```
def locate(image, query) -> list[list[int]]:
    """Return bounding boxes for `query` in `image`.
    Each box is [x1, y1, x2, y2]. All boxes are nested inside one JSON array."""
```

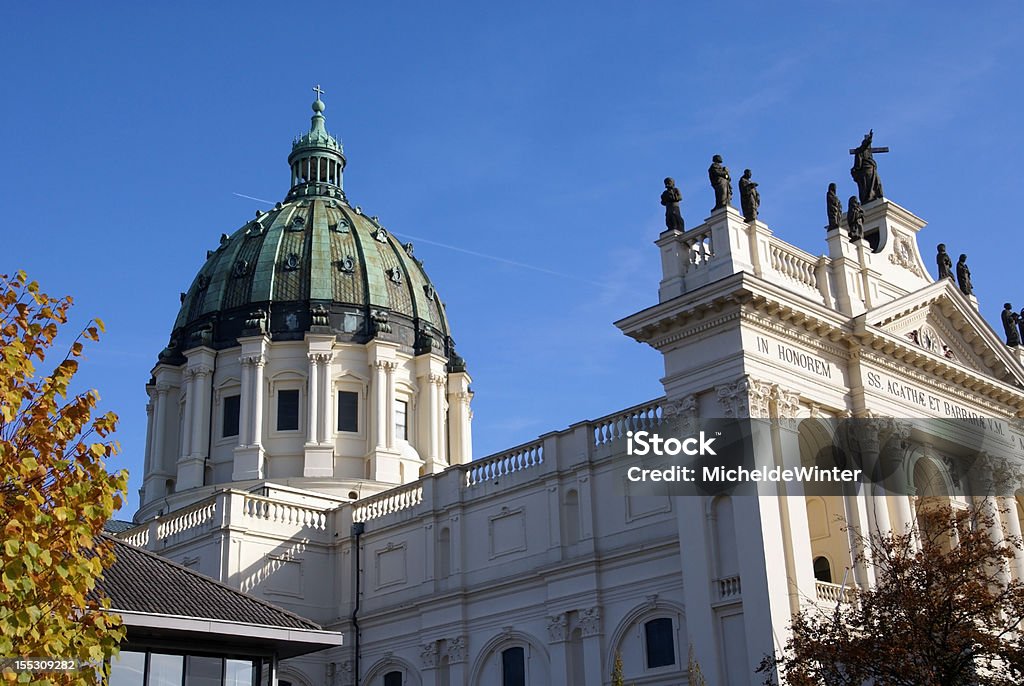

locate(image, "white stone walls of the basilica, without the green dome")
[[123, 200, 1024, 686]]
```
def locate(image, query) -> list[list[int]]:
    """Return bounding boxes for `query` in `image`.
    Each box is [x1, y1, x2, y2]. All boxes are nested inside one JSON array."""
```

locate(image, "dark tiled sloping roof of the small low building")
[[97, 535, 321, 631]]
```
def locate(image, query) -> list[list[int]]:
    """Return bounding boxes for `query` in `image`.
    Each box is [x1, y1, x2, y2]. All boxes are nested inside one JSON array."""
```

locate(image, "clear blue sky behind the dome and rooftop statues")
[[0, 1, 1024, 512]]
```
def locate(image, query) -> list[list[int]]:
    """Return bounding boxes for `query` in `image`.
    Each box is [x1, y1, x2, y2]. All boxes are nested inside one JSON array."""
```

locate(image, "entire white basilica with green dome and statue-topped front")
[[117, 92, 1024, 686]]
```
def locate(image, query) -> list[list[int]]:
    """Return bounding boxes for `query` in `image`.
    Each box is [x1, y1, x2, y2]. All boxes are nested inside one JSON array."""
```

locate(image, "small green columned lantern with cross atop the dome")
[[288, 84, 345, 201]]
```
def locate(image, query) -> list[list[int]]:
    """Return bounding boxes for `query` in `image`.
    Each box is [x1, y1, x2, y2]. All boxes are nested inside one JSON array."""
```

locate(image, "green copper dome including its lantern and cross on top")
[[160, 93, 462, 368]]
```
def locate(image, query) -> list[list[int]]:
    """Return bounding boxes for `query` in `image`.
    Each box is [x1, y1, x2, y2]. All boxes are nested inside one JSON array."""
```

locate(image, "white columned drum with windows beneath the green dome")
[[136, 333, 472, 520]]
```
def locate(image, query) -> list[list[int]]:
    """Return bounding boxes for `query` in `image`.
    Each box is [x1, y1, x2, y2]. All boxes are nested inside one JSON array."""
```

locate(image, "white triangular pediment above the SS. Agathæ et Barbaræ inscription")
[[857, 280, 1024, 387]]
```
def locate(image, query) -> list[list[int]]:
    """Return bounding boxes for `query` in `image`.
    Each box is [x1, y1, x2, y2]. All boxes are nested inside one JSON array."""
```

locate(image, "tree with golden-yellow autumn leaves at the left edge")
[[0, 272, 126, 684]]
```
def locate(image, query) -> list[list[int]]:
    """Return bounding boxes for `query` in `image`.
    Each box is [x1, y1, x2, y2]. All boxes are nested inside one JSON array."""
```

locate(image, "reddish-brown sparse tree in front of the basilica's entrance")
[[762, 506, 1024, 686]]
